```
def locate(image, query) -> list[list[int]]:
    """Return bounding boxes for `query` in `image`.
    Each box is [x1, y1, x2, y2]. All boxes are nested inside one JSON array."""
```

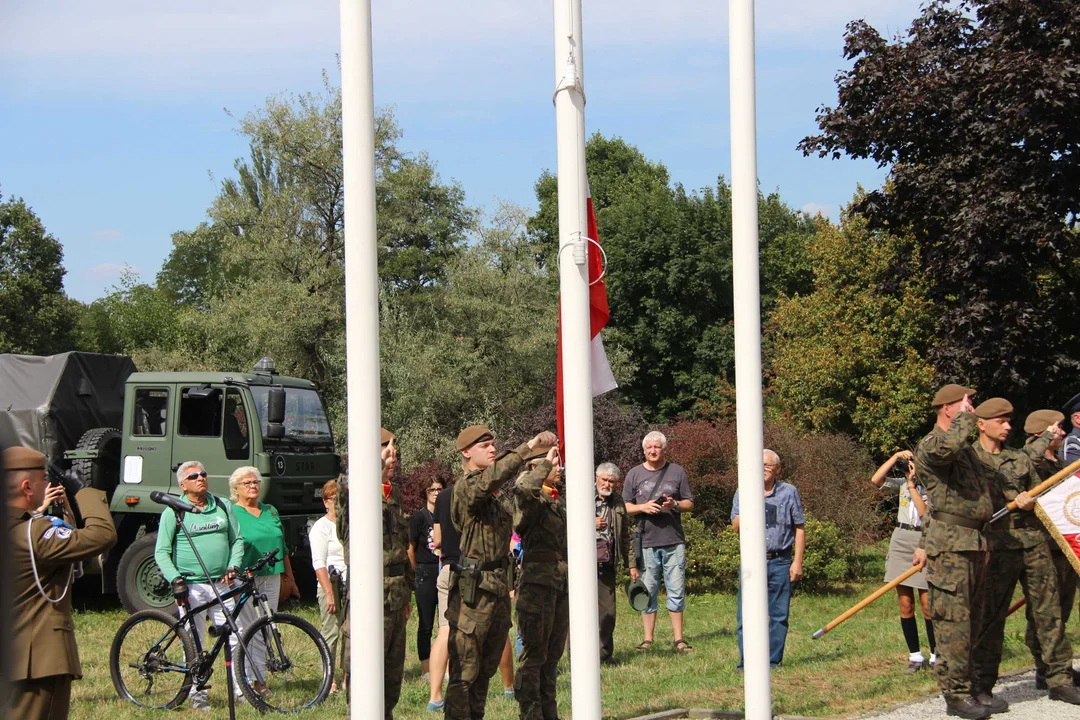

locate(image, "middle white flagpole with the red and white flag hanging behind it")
[[554, 0, 600, 720]]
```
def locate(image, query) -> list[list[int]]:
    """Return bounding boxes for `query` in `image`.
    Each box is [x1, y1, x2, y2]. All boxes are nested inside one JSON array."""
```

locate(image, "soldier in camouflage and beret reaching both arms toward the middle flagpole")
[[445, 425, 557, 720]]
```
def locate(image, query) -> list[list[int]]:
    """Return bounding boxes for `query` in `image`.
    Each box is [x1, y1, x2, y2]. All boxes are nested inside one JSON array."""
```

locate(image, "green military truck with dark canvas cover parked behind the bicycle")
[[0, 352, 340, 612]]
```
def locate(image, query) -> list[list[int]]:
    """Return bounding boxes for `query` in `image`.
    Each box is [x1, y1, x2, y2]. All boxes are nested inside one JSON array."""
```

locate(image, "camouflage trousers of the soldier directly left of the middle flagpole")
[[514, 583, 570, 720]]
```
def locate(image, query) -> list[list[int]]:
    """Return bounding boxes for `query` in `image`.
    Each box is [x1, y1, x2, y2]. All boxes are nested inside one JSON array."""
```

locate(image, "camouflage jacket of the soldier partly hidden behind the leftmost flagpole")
[[336, 475, 414, 613]]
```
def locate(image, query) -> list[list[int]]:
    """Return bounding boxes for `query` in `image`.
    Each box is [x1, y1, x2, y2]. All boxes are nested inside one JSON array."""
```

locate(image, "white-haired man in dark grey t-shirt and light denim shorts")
[[622, 432, 693, 653]]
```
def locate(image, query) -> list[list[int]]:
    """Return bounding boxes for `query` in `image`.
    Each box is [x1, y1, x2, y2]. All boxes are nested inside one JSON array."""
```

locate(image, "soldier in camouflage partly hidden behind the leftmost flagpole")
[[337, 429, 413, 720]]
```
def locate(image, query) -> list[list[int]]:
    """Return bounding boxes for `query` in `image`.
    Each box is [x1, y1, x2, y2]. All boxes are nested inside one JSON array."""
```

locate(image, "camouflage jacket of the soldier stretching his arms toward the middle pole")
[[450, 444, 529, 598]]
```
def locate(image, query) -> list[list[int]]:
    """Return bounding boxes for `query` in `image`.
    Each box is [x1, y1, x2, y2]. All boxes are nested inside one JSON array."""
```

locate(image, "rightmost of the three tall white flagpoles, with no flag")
[[728, 0, 772, 720]]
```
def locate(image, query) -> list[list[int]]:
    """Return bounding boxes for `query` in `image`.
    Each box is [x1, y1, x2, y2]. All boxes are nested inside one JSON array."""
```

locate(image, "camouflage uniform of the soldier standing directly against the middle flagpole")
[[514, 460, 570, 720]]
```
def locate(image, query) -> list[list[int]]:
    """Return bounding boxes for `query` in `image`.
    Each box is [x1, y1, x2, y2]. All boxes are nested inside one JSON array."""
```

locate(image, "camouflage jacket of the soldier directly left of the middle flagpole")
[[514, 460, 566, 590]]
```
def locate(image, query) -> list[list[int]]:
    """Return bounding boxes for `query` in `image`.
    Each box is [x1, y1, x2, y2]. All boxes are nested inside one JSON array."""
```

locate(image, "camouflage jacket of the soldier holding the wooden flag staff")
[[974, 444, 1047, 549]]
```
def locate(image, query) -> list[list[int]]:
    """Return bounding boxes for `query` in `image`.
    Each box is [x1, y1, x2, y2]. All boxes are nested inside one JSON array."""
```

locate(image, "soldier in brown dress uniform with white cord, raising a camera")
[[3, 448, 117, 720]]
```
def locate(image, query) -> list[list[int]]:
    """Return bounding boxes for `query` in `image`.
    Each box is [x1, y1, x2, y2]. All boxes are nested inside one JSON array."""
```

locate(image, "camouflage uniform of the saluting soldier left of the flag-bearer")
[[915, 412, 994, 702]]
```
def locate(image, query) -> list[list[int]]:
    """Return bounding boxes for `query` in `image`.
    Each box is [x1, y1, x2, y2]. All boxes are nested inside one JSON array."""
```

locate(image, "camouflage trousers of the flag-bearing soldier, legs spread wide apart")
[[972, 542, 1072, 692]]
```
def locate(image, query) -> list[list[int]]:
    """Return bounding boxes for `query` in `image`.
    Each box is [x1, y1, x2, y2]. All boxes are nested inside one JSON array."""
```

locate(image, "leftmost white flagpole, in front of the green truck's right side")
[[341, 0, 383, 718]]
